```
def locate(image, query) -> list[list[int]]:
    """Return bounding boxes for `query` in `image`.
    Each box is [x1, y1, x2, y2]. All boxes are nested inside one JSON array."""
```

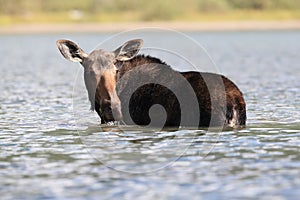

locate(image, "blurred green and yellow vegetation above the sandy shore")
[[0, 0, 300, 25]]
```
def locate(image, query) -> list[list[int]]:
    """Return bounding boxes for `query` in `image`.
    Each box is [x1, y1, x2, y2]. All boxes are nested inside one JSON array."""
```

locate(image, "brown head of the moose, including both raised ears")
[[56, 39, 143, 123]]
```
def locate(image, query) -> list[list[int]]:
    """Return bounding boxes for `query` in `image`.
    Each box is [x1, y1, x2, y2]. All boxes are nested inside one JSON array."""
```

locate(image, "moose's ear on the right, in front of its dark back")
[[114, 39, 143, 61]]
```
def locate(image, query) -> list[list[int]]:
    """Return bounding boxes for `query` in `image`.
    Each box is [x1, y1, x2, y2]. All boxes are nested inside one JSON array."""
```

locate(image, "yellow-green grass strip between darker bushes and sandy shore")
[[0, 10, 300, 25]]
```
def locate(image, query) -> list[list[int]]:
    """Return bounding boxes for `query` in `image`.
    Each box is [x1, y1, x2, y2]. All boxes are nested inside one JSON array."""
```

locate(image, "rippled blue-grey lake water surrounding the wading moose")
[[0, 31, 300, 199]]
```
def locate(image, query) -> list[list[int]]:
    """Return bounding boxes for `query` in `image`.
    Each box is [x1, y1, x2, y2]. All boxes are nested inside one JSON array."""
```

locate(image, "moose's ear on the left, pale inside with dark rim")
[[56, 40, 88, 62]]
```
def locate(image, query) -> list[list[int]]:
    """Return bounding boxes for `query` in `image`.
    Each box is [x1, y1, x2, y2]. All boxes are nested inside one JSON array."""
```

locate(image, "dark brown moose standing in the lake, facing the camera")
[[56, 39, 246, 128]]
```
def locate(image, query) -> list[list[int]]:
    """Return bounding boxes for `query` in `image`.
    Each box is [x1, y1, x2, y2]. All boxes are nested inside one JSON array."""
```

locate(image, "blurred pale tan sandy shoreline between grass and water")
[[0, 20, 300, 35]]
